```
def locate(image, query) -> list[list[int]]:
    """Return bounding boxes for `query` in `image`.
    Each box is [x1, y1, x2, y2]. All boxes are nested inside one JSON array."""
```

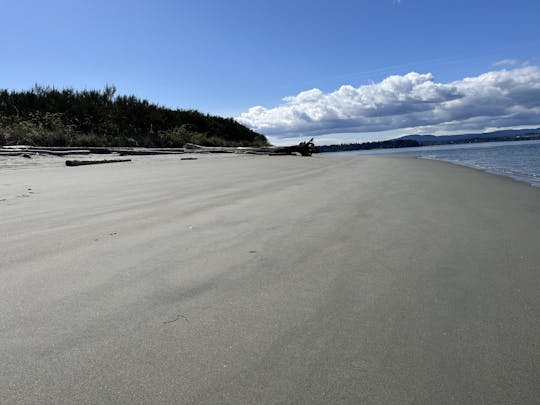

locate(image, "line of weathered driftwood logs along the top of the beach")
[[0, 139, 315, 160]]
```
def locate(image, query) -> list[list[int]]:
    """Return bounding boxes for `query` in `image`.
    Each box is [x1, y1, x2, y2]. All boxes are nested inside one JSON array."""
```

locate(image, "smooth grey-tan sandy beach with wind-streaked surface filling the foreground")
[[0, 156, 540, 404]]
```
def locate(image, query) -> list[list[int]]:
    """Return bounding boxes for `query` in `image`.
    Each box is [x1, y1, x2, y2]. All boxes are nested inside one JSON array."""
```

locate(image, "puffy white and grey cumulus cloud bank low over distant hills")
[[237, 66, 540, 138]]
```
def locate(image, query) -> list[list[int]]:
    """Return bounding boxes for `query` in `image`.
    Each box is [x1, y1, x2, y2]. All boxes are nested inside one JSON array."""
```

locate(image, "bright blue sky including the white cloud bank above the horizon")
[[0, 0, 540, 144]]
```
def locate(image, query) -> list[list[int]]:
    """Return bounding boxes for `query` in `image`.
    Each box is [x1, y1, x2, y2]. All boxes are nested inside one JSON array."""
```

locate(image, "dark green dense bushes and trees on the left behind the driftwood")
[[0, 86, 268, 147]]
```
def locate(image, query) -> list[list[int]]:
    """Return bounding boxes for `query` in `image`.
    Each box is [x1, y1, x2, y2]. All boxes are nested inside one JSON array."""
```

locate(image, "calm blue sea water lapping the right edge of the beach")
[[324, 141, 540, 187]]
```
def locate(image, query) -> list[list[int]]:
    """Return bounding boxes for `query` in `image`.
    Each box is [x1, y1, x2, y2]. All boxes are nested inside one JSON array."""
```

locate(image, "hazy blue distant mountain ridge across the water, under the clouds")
[[396, 128, 540, 146]]
